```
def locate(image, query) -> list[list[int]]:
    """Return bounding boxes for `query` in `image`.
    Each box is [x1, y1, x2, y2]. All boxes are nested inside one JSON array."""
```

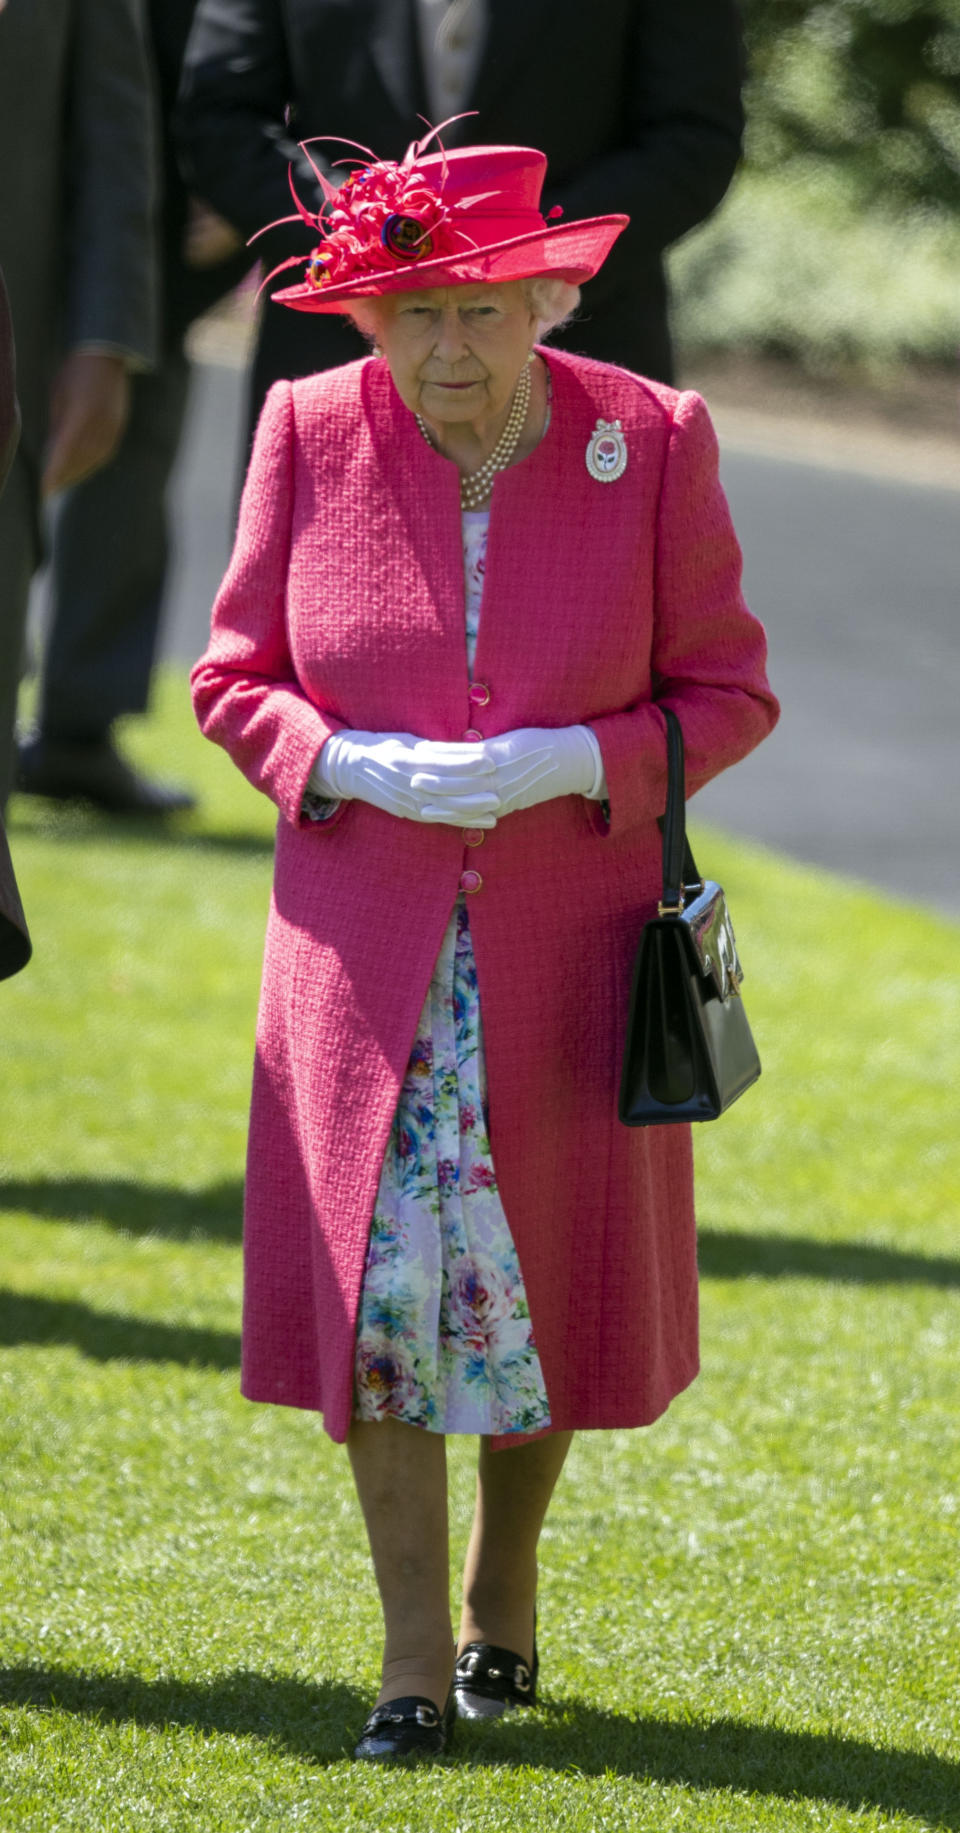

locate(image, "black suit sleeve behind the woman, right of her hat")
[[548, 0, 744, 258]]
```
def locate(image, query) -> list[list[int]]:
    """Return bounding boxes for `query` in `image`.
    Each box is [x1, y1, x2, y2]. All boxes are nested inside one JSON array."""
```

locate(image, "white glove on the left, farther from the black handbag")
[[308, 731, 500, 827]]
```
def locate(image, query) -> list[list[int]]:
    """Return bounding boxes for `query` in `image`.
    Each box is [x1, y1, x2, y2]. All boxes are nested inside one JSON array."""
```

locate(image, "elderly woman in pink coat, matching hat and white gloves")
[[192, 145, 777, 1760]]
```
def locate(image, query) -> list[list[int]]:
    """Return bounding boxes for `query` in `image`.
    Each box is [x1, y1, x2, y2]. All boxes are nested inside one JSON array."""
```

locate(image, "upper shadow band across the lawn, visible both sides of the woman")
[[7, 1177, 960, 1287]]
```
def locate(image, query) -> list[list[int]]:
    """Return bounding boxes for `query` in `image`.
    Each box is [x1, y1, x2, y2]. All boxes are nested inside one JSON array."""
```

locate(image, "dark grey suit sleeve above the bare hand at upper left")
[[60, 0, 158, 365]]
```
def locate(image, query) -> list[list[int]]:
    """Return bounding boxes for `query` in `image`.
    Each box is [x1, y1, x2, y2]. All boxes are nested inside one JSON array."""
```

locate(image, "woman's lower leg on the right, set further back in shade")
[[458, 1432, 573, 1664]]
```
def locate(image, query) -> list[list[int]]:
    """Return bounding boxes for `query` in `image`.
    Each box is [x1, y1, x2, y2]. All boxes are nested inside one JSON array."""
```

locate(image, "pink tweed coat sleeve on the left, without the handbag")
[[191, 381, 343, 832]]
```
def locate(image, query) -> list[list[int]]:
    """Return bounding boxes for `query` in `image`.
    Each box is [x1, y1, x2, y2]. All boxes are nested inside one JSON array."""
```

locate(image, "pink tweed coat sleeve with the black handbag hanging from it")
[[590, 394, 780, 834]]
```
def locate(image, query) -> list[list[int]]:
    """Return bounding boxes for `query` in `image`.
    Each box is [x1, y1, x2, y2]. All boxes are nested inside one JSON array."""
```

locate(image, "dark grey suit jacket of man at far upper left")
[[0, 0, 156, 450]]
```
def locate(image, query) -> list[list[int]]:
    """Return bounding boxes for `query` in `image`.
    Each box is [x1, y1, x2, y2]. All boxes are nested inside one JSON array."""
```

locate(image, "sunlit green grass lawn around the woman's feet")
[[0, 676, 960, 1833]]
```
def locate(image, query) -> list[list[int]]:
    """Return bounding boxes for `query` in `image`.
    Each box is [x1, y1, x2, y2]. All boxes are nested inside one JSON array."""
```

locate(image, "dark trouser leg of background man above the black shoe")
[[38, 350, 191, 742]]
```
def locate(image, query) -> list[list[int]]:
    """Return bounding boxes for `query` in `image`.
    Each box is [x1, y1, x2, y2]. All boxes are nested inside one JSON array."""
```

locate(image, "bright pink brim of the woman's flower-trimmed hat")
[[271, 216, 630, 312]]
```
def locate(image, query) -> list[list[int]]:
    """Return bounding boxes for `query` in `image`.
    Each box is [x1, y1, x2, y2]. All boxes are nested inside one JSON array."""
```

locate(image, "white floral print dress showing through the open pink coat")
[[354, 510, 550, 1435]]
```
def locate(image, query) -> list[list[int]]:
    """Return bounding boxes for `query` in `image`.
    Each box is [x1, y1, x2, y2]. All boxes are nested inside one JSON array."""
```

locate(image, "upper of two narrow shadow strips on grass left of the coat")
[[0, 1177, 244, 1241]]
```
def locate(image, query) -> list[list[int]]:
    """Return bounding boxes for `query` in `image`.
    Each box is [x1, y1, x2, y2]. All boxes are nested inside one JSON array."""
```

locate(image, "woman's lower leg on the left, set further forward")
[[346, 1419, 454, 1710]]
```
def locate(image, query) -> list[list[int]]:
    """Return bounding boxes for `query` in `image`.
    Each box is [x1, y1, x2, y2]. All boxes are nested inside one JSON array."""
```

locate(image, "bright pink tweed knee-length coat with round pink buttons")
[[192, 350, 777, 1439]]
